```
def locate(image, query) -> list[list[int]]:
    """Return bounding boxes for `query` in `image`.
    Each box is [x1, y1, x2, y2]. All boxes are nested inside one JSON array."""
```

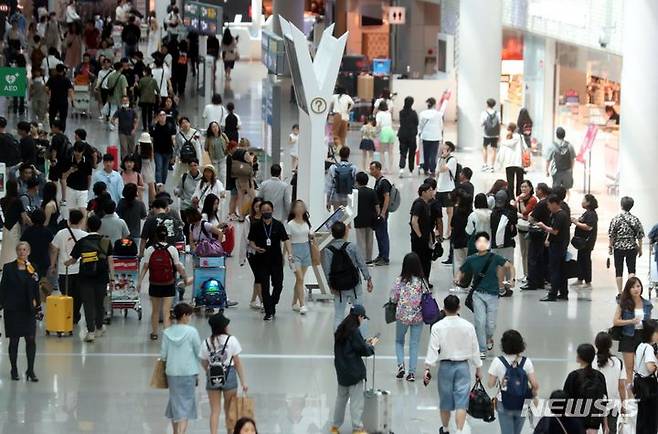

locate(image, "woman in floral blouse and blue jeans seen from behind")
[[389, 252, 429, 382]]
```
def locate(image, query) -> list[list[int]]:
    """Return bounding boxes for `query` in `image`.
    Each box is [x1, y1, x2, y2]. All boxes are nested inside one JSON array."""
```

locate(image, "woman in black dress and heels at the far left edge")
[[0, 241, 41, 383]]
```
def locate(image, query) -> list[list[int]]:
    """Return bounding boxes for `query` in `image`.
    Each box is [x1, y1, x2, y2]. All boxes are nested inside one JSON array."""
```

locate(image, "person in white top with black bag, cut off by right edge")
[[633, 320, 658, 434]]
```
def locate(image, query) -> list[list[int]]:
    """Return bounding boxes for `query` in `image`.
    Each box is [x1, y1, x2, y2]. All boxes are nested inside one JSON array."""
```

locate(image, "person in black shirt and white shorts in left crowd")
[[60, 142, 92, 215]]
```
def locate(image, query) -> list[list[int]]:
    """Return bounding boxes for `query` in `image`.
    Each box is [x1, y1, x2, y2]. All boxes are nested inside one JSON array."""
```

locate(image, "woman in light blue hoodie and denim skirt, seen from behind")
[[156, 302, 201, 434]]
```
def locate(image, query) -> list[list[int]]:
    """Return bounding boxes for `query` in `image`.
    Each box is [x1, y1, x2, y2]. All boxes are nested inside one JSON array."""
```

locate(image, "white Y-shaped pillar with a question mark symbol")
[[279, 15, 347, 222]]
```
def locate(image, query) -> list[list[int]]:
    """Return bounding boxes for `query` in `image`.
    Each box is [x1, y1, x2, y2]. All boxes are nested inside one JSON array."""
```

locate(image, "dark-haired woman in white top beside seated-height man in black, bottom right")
[[593, 332, 626, 432]]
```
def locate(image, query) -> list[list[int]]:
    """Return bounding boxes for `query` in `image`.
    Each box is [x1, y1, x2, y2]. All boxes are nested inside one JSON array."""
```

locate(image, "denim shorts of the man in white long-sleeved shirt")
[[436, 360, 471, 411]]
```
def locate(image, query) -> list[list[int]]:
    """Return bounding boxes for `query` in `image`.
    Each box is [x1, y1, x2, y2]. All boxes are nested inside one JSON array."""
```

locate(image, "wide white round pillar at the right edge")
[[619, 0, 658, 227]]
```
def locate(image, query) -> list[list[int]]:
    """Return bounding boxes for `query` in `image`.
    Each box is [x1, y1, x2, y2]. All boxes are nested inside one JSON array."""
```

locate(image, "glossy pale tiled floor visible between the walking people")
[[0, 64, 646, 434]]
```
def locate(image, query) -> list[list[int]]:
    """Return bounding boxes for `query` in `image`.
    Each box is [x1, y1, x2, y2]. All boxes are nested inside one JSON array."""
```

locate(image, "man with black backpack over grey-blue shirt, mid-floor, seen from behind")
[[322, 224, 373, 330]]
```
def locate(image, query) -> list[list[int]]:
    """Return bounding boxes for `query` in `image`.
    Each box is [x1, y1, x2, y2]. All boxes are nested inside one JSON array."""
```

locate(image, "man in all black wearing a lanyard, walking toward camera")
[[247, 200, 293, 321]]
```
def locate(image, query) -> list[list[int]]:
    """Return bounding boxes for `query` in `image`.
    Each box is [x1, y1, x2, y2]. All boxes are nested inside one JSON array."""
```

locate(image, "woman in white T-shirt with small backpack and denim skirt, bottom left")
[[199, 312, 249, 434]]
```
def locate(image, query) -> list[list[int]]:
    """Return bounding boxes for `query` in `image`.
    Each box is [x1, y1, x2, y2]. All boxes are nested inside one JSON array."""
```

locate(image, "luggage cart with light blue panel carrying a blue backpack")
[[192, 256, 228, 315]]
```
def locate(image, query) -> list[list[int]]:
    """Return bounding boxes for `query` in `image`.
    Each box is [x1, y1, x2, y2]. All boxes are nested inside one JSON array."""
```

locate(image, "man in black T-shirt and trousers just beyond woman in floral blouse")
[[409, 184, 434, 281]]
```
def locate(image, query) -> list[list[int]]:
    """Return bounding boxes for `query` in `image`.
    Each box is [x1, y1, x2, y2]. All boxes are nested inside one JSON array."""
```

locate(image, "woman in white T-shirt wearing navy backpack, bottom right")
[[487, 330, 539, 434]]
